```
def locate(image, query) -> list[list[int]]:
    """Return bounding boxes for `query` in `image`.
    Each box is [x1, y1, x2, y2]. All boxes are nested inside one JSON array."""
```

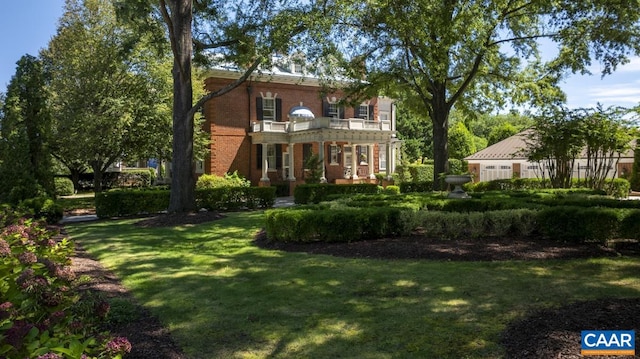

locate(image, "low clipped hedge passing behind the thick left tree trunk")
[[95, 187, 276, 218]]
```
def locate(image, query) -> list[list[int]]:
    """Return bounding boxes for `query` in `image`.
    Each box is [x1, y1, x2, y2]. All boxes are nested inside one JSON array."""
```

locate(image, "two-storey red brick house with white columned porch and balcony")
[[204, 62, 400, 191]]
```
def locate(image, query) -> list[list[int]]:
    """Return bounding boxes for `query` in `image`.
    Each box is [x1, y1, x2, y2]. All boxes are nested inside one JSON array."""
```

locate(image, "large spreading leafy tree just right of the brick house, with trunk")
[[330, 0, 640, 190]]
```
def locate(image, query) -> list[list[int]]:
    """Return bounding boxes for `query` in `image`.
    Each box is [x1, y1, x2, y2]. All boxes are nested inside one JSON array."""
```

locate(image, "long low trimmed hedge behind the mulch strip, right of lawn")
[[266, 194, 640, 243]]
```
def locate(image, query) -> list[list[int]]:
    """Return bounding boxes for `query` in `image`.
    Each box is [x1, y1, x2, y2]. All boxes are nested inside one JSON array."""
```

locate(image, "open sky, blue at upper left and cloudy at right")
[[0, 0, 640, 108]]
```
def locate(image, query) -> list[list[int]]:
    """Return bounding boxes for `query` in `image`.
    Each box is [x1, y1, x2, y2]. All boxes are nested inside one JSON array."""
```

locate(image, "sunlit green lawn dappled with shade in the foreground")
[[67, 212, 640, 359]]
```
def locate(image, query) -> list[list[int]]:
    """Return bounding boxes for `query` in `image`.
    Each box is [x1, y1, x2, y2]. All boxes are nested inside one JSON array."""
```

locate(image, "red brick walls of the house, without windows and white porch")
[[204, 68, 395, 190]]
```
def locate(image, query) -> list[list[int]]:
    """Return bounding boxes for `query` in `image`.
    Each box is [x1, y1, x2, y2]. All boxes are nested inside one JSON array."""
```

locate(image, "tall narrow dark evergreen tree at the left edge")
[[0, 55, 55, 203]]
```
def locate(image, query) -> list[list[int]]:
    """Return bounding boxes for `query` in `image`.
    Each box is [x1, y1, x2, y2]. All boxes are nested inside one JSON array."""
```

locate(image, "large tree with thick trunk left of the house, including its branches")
[[116, 0, 326, 212]]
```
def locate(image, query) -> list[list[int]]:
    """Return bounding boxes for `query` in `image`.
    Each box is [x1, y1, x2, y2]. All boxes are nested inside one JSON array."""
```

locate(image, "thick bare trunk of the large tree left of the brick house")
[[168, 0, 195, 212]]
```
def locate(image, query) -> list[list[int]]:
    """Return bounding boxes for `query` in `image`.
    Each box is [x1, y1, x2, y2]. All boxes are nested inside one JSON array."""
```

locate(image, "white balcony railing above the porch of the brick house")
[[253, 117, 391, 133]]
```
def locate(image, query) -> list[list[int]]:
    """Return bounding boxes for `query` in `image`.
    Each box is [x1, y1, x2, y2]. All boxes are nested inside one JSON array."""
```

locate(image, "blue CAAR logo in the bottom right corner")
[[581, 330, 636, 355]]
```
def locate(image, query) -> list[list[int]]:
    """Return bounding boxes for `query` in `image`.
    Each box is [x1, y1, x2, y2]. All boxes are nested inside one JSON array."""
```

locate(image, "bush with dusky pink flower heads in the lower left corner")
[[0, 207, 131, 359]]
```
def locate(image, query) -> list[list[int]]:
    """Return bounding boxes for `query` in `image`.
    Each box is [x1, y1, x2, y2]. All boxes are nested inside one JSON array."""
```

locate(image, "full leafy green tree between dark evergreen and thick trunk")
[[42, 0, 170, 191]]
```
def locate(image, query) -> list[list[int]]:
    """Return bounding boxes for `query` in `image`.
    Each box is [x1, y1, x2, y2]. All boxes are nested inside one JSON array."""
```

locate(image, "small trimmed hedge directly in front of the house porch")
[[293, 183, 380, 204]]
